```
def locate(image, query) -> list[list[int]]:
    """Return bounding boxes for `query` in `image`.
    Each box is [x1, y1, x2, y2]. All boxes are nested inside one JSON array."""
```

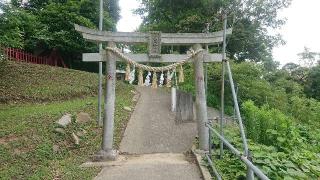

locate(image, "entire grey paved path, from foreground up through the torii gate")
[[95, 87, 201, 180]]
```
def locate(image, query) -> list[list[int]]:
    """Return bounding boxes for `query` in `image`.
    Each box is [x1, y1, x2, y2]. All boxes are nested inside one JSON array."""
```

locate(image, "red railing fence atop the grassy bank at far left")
[[1, 48, 54, 65]]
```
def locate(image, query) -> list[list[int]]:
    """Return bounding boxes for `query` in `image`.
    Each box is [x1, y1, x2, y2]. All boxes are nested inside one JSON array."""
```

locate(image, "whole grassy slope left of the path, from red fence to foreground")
[[0, 63, 133, 179]]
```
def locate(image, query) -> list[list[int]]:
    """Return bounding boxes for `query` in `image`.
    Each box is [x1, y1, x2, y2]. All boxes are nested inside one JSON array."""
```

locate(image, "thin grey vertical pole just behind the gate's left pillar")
[[97, 0, 103, 126]]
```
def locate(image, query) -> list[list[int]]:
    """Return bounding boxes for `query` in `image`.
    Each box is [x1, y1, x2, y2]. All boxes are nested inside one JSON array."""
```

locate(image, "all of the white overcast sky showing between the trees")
[[117, 0, 320, 65]]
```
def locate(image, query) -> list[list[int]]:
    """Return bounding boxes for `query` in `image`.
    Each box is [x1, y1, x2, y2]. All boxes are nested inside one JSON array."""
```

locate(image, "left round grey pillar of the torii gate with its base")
[[96, 42, 117, 160]]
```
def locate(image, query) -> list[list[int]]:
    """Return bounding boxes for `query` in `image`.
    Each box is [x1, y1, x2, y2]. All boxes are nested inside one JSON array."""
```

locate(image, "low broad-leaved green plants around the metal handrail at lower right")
[[208, 114, 320, 179]]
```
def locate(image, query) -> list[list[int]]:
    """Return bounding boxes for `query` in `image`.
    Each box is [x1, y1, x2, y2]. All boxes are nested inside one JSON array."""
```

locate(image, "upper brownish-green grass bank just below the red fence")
[[0, 61, 98, 103]]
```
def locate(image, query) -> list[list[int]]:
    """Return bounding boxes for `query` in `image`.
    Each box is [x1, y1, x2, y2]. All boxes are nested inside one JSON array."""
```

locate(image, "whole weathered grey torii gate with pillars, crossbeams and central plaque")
[[75, 25, 232, 160]]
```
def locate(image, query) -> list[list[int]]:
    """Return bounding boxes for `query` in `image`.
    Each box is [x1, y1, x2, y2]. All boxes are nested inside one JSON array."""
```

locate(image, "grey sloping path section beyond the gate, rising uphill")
[[120, 87, 197, 154]]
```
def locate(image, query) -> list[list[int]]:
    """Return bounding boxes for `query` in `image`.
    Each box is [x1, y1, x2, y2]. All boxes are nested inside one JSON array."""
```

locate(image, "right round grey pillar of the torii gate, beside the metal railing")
[[193, 44, 209, 151]]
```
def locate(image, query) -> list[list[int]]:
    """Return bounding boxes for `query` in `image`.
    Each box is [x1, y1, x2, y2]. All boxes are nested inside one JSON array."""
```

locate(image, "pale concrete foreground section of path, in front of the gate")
[[95, 153, 201, 180]]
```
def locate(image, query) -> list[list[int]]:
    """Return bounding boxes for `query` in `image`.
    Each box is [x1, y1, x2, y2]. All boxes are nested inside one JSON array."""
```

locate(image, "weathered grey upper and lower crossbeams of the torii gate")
[[75, 25, 232, 63]]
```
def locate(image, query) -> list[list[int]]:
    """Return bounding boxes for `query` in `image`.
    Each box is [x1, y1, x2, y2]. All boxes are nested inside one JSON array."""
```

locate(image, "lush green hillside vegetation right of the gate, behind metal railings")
[[180, 61, 320, 179]]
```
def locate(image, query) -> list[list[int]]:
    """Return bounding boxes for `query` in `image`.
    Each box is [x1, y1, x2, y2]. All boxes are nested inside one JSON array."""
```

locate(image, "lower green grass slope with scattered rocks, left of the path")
[[0, 83, 133, 179]]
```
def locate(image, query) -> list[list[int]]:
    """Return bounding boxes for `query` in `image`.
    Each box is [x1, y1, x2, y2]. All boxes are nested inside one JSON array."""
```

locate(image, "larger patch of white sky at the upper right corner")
[[273, 0, 320, 65]]
